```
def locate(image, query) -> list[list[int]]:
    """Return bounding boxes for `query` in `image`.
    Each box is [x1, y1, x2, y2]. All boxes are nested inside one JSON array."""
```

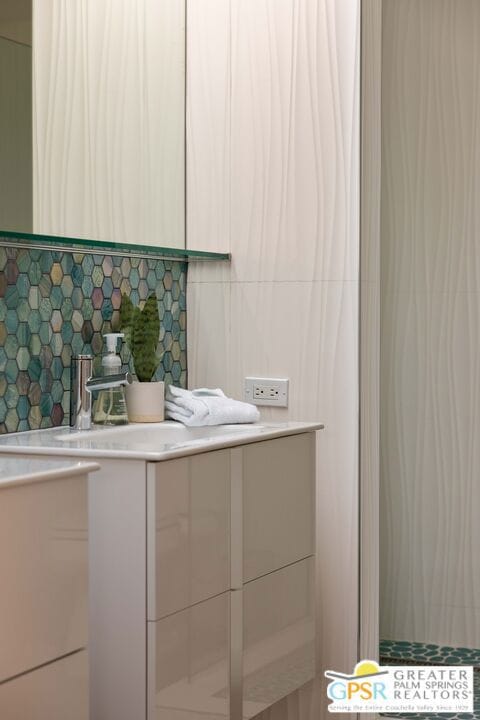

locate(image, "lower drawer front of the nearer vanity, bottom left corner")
[[0, 650, 88, 720]]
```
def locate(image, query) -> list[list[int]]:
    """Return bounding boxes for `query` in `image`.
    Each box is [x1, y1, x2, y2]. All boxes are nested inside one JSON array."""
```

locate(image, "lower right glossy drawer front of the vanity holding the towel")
[[243, 558, 315, 718]]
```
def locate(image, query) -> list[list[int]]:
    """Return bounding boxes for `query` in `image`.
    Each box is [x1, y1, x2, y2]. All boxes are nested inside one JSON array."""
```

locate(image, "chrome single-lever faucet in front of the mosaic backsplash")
[[70, 355, 132, 430]]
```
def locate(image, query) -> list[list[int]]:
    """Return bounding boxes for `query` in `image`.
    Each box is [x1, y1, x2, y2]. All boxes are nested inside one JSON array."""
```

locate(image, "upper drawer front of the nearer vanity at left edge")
[[0, 476, 88, 680]]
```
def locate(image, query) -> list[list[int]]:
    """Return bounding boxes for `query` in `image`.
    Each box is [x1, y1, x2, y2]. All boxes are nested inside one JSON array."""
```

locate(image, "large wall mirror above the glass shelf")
[[0, 0, 185, 249]]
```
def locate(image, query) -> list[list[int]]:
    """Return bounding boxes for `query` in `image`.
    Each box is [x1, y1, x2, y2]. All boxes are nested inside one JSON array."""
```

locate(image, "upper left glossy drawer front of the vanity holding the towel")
[[147, 450, 230, 620]]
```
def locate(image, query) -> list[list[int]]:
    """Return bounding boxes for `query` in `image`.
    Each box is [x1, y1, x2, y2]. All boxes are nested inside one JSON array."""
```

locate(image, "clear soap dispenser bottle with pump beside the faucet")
[[93, 333, 128, 425]]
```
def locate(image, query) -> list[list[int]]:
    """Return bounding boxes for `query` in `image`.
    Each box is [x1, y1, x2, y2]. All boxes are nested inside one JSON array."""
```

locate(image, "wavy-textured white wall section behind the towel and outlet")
[[187, 0, 359, 720]]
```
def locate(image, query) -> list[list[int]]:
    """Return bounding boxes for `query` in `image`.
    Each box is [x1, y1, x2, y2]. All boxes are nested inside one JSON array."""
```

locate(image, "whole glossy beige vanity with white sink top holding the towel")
[[0, 422, 321, 720]]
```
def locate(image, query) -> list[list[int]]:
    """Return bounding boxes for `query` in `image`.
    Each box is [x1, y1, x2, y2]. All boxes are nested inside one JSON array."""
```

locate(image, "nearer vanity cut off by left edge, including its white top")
[[0, 456, 98, 720]]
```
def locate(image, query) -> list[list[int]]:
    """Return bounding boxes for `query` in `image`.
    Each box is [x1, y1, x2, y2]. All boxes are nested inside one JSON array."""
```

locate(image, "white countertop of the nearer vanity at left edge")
[[0, 456, 99, 490]]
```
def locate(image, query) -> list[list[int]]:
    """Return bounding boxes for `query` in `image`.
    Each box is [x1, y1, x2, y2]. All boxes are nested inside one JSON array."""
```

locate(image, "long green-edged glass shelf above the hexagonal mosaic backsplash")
[[0, 230, 230, 262]]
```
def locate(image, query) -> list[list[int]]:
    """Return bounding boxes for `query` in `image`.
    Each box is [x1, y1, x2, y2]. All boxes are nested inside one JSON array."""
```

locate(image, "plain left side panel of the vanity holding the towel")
[[88, 459, 147, 720]]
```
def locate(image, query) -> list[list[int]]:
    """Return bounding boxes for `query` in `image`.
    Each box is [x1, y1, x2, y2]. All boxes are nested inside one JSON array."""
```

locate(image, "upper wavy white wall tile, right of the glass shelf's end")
[[231, 0, 359, 281]]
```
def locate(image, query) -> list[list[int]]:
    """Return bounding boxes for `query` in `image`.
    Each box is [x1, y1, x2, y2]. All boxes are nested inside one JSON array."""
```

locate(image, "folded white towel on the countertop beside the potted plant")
[[165, 385, 260, 427]]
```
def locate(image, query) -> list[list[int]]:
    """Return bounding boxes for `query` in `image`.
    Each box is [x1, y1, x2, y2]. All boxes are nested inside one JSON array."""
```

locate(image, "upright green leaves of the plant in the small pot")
[[120, 293, 161, 382]]
